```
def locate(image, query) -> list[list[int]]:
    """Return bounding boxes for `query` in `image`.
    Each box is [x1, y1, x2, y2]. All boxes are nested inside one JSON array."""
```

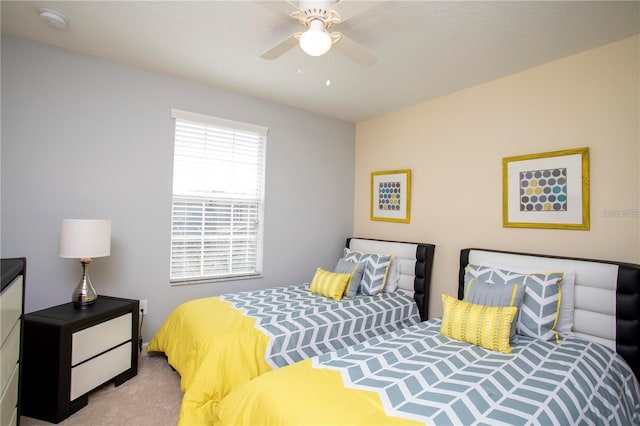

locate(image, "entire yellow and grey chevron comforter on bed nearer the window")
[[147, 284, 420, 425]]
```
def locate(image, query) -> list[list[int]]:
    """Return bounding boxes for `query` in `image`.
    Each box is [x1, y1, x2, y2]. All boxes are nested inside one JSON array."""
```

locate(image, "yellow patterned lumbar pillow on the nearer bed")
[[440, 294, 518, 354]]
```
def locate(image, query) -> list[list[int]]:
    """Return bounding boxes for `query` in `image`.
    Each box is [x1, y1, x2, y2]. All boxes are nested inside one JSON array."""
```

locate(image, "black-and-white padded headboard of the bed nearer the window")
[[347, 237, 436, 321]]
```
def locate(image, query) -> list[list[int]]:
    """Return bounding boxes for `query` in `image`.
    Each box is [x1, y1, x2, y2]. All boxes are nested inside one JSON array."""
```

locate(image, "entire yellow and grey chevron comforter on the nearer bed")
[[214, 319, 640, 426]]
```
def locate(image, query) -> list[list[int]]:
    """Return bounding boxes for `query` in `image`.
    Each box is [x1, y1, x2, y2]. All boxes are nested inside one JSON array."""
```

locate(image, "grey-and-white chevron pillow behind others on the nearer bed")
[[464, 265, 564, 340]]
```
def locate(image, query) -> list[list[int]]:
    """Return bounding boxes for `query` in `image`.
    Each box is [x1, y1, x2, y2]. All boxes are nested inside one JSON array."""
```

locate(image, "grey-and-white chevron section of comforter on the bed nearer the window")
[[220, 284, 420, 369]]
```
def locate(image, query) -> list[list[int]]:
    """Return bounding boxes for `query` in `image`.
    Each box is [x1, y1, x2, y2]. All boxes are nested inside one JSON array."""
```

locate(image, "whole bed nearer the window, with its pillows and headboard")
[[147, 238, 435, 425]]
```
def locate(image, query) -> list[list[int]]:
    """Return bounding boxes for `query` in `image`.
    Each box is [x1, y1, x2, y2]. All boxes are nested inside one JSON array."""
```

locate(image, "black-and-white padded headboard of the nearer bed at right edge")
[[458, 248, 640, 378]]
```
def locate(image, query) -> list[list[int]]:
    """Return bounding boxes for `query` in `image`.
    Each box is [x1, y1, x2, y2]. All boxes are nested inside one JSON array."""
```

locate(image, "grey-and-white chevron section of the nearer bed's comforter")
[[313, 318, 640, 425]]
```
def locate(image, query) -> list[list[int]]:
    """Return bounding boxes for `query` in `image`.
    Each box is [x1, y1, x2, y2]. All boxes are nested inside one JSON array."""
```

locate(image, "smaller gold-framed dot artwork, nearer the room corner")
[[371, 169, 411, 223]]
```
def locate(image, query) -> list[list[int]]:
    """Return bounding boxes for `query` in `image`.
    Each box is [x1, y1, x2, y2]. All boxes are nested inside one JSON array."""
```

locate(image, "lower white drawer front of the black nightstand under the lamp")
[[69, 340, 133, 401]]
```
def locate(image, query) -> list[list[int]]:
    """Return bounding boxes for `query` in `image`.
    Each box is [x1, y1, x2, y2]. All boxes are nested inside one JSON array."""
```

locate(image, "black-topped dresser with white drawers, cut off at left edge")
[[0, 258, 26, 426]]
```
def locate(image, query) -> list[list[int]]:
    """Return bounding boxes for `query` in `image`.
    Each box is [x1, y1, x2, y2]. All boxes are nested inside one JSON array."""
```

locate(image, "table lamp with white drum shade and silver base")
[[60, 219, 111, 307]]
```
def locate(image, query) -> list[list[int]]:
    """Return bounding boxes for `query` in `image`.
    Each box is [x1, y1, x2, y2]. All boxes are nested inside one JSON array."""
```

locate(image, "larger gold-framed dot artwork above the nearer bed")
[[502, 148, 589, 230]]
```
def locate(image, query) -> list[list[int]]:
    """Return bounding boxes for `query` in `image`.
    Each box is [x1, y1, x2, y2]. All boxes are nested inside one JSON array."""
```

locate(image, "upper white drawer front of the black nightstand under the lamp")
[[71, 313, 132, 364]]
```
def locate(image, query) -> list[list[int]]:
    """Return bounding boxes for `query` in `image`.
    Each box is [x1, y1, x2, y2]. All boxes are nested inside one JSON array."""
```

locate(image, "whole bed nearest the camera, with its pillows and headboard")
[[214, 249, 640, 425]]
